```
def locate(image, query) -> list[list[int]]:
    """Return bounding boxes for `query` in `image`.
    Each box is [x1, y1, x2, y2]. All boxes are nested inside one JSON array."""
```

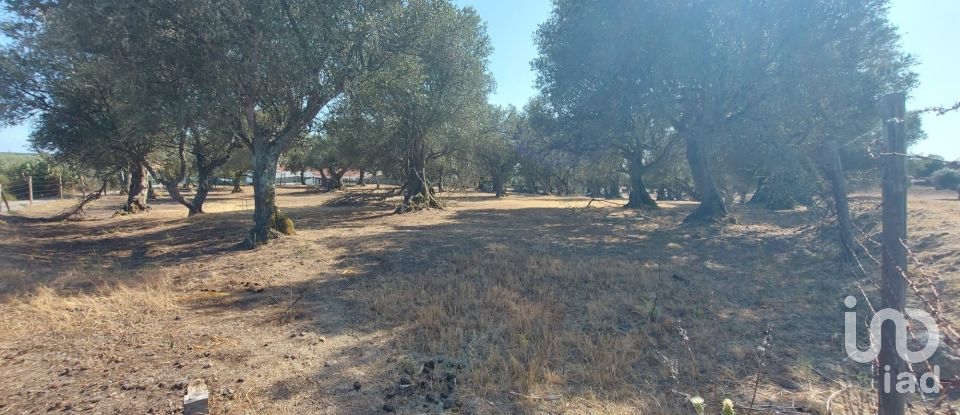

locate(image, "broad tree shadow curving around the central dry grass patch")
[[189, 205, 856, 410]]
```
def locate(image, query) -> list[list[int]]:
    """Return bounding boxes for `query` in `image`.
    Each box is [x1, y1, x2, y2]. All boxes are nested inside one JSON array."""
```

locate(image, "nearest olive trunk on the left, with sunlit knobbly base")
[[245, 147, 280, 248]]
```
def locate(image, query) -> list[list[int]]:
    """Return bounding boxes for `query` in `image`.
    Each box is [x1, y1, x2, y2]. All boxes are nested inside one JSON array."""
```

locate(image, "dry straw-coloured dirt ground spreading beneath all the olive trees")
[[0, 187, 960, 414]]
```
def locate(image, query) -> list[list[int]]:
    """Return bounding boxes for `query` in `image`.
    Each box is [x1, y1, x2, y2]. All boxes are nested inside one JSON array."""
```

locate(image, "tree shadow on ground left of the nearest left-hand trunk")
[[0, 212, 249, 296]]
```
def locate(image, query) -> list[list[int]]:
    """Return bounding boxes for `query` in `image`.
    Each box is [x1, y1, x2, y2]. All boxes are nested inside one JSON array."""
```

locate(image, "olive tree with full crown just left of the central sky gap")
[[332, 0, 492, 212]]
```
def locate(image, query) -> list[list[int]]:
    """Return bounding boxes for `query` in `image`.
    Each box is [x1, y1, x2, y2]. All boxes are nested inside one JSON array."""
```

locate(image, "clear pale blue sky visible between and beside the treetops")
[[0, 0, 960, 159]]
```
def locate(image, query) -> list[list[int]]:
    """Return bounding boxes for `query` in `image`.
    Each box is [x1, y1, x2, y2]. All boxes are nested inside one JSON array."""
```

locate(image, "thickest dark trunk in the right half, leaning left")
[[683, 135, 727, 223]]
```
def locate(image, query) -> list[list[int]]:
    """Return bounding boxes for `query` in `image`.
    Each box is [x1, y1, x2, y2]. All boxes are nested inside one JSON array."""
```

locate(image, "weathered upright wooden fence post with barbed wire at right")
[[878, 93, 907, 415]]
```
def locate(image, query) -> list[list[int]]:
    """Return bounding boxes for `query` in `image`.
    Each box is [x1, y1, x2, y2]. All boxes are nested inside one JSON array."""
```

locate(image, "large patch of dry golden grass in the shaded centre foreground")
[[364, 244, 749, 413]]
